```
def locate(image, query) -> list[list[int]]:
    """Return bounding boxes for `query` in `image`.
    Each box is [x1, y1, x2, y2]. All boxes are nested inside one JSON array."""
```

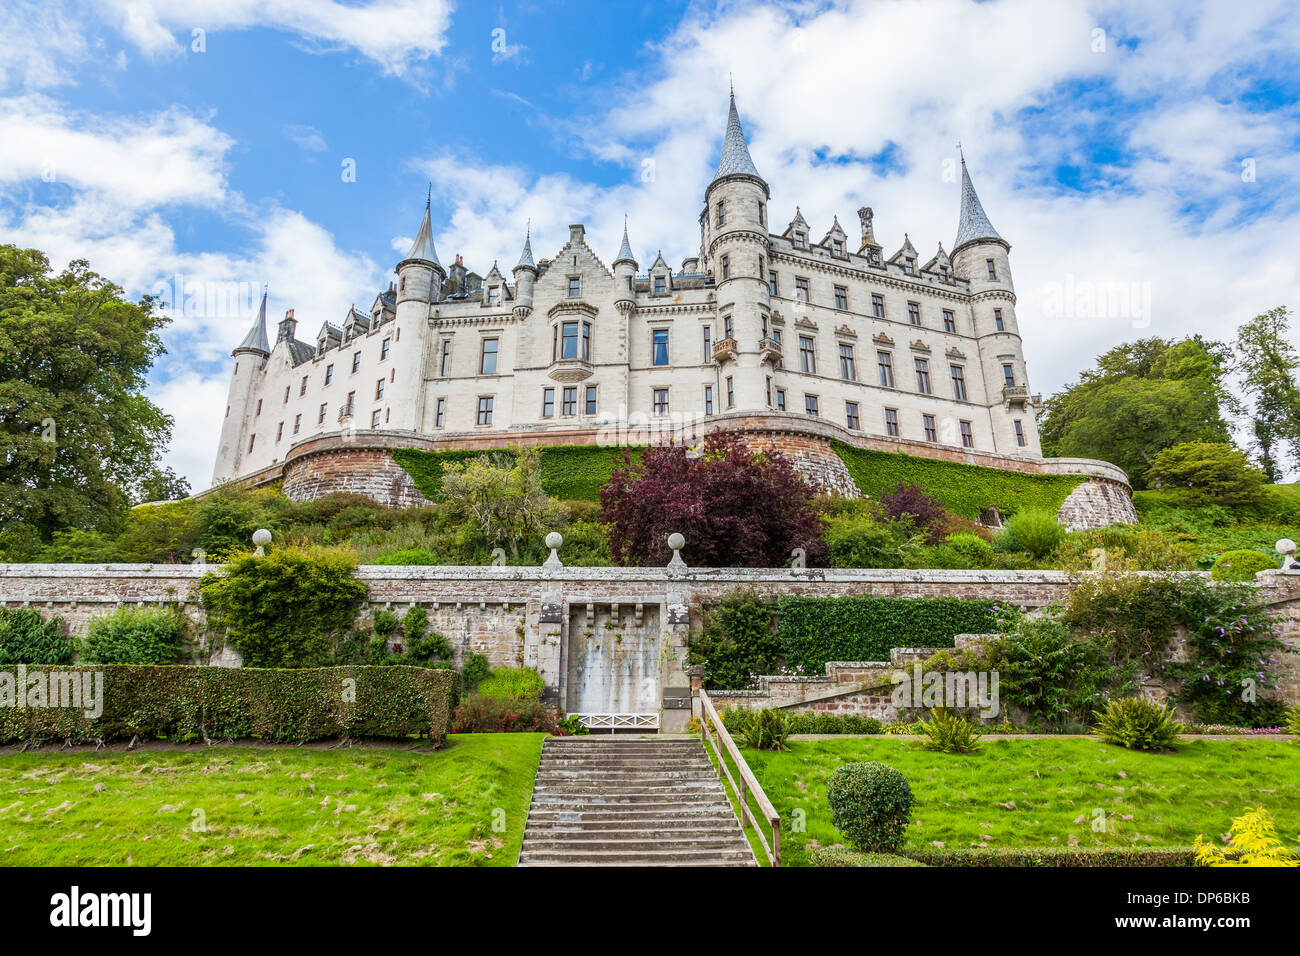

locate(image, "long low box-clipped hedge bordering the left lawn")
[[0, 665, 455, 744]]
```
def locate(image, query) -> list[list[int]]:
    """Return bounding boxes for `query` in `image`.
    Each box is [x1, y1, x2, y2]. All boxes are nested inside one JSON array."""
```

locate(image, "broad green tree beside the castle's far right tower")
[[1040, 337, 1240, 488]]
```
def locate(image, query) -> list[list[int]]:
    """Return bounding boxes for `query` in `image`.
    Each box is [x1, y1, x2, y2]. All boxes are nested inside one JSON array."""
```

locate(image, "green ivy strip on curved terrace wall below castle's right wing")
[[831, 440, 1087, 519]]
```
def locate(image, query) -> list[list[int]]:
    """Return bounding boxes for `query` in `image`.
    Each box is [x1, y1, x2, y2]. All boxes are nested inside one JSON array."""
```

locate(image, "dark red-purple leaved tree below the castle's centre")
[[601, 432, 827, 567]]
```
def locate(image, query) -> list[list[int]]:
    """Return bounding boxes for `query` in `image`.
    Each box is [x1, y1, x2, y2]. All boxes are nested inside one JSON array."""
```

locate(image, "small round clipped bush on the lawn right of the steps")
[[826, 760, 913, 853]]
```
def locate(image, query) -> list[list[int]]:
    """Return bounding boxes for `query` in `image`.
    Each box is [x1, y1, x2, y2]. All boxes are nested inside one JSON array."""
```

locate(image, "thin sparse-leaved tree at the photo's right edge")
[[1236, 306, 1300, 481]]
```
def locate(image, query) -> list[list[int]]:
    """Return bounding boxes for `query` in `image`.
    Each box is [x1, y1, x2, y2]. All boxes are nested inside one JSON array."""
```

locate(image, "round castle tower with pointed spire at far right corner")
[[950, 156, 1043, 457]]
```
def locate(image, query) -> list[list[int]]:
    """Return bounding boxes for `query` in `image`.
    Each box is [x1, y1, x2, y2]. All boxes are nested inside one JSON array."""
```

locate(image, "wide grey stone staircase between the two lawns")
[[519, 736, 758, 866]]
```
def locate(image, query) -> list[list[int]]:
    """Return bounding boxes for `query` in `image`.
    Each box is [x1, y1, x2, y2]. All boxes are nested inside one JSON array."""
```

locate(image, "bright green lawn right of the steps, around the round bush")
[[744, 737, 1300, 866]]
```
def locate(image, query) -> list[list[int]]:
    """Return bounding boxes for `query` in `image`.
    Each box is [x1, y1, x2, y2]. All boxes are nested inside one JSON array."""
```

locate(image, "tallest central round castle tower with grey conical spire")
[[702, 92, 774, 411]]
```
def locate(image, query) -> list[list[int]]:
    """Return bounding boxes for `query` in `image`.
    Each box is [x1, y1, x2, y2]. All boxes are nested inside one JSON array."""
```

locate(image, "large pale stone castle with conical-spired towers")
[[213, 95, 1131, 528]]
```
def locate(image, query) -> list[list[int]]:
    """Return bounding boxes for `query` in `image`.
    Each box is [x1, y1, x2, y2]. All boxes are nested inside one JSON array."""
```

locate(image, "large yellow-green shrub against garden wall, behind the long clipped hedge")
[[199, 548, 369, 667]]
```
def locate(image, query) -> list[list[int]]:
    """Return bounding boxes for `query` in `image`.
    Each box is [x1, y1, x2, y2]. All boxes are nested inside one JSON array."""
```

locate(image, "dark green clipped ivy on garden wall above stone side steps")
[[776, 597, 1001, 674]]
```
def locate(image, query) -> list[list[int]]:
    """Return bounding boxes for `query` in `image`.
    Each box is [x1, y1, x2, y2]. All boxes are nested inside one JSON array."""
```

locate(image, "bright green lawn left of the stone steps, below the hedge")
[[0, 734, 545, 866]]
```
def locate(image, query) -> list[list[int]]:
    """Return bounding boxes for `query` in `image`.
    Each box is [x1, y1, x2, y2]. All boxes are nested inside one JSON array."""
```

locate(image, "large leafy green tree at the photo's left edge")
[[0, 245, 172, 540]]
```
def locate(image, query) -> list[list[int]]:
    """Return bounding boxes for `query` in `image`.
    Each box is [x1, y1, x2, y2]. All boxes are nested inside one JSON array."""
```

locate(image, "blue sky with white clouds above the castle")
[[0, 0, 1300, 490]]
